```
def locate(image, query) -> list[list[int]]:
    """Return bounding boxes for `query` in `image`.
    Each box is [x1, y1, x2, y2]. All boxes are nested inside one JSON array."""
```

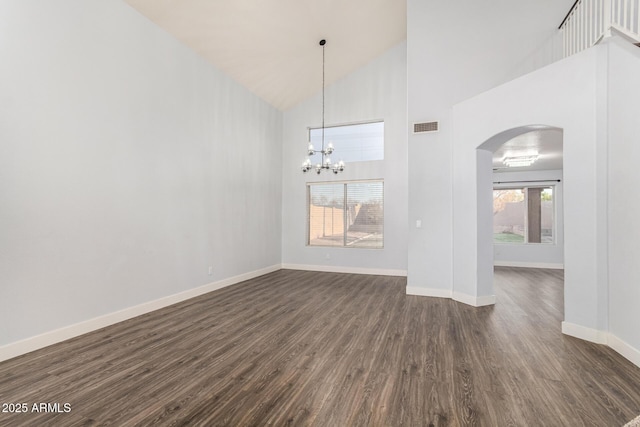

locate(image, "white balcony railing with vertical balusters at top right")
[[559, 0, 640, 57]]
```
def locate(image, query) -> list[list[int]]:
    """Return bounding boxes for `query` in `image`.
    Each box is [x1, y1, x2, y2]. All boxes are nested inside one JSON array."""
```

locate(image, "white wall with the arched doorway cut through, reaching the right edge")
[[453, 38, 640, 366]]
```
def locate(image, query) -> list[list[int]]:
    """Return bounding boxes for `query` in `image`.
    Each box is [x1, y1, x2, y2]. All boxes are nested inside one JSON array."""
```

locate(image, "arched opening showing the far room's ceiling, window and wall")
[[476, 125, 564, 318]]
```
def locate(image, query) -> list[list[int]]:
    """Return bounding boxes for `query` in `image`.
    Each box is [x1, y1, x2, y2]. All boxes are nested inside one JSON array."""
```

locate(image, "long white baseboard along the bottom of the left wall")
[[0, 264, 281, 362]]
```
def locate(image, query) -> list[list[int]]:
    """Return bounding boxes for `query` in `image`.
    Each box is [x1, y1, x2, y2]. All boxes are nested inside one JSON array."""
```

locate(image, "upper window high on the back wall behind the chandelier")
[[309, 122, 384, 163]]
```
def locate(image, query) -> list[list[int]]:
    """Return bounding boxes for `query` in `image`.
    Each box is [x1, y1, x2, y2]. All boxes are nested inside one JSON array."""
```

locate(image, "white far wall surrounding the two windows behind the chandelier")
[[282, 43, 407, 275]]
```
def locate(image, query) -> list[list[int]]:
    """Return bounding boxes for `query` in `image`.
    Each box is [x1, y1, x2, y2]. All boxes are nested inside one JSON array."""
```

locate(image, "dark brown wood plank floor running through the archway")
[[0, 268, 640, 426]]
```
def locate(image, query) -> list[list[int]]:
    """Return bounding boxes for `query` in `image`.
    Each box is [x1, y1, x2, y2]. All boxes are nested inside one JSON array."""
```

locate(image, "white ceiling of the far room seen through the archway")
[[493, 129, 562, 172]]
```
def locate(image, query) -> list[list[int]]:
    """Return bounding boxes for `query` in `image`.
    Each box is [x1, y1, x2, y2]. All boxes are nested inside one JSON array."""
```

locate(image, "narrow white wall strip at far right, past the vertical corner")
[[608, 39, 640, 366]]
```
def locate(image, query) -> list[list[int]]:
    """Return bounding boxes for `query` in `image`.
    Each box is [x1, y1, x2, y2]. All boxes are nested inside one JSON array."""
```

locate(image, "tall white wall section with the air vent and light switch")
[[407, 0, 573, 296]]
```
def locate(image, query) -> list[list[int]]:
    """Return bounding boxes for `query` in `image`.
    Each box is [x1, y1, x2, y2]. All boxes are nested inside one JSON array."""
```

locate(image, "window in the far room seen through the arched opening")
[[493, 187, 555, 244]]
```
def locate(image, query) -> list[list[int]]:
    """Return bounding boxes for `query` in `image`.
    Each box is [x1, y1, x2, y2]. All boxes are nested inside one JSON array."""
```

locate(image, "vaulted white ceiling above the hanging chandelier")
[[125, 0, 407, 111]]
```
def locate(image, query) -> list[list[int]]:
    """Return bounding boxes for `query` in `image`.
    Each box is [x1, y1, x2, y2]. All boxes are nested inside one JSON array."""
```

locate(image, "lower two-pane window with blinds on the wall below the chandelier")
[[307, 181, 384, 248]]
